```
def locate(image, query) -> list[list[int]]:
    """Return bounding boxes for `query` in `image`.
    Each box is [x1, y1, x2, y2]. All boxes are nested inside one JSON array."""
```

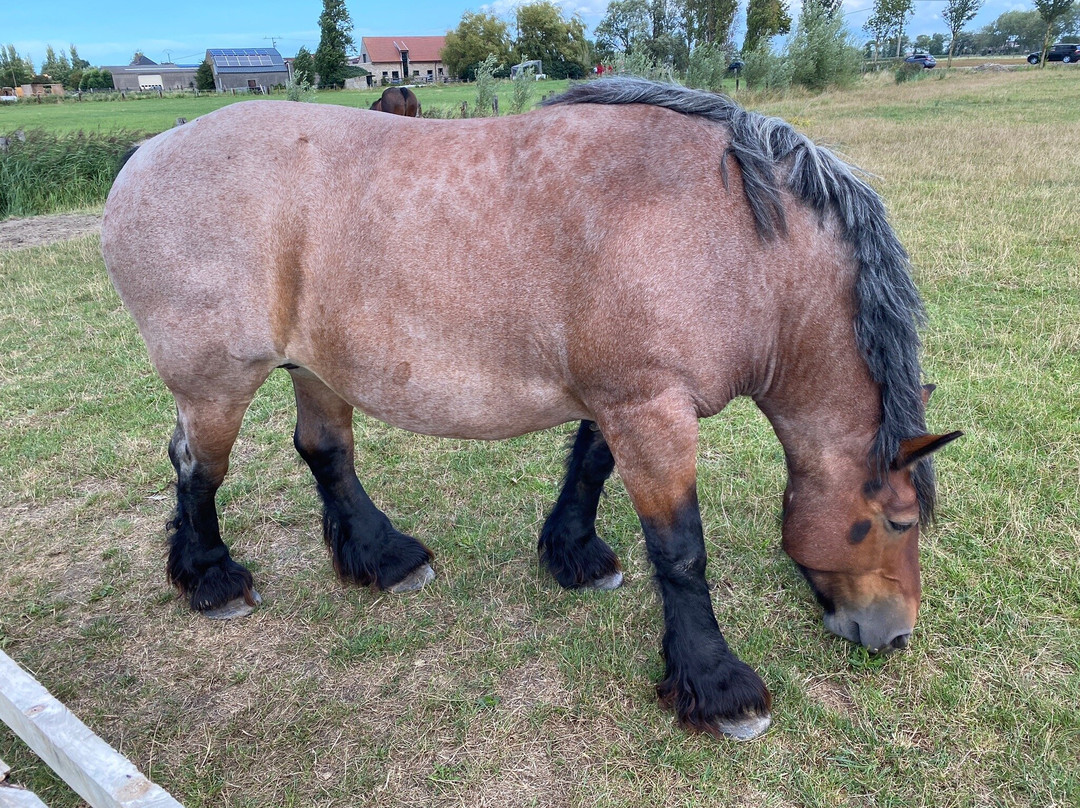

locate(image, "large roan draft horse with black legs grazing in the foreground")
[[102, 79, 959, 738]]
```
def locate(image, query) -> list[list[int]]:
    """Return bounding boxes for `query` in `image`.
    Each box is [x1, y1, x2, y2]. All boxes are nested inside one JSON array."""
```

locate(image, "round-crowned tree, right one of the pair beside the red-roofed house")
[[514, 0, 591, 79]]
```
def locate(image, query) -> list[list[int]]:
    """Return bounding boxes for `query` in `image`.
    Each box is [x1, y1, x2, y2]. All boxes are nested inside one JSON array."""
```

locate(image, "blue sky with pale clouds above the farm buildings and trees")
[[8, 0, 1032, 68]]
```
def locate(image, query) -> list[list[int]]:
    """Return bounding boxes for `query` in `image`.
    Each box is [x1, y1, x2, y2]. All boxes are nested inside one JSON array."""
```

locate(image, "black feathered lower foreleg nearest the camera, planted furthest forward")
[[642, 496, 771, 735]]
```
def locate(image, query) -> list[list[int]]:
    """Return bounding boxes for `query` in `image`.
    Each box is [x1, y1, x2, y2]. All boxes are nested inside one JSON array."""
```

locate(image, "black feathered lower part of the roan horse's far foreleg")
[[538, 421, 620, 588]]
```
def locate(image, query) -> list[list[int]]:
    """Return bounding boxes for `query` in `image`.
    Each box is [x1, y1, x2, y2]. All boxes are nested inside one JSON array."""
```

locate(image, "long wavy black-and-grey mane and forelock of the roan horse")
[[544, 78, 934, 523]]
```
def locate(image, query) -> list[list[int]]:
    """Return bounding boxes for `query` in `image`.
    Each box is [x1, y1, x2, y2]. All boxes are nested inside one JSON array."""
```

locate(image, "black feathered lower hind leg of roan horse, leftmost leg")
[[165, 428, 255, 610]]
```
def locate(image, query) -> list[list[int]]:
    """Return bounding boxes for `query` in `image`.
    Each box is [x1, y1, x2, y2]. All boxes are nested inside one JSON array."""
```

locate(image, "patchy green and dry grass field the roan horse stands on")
[[0, 70, 1080, 808]]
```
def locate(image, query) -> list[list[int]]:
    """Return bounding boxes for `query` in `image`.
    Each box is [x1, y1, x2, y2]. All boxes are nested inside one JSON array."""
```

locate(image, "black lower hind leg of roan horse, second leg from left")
[[294, 428, 432, 589]]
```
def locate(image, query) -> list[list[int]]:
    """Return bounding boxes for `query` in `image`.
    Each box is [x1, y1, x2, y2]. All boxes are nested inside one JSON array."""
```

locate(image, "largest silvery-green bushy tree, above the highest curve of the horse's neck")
[[787, 0, 862, 91]]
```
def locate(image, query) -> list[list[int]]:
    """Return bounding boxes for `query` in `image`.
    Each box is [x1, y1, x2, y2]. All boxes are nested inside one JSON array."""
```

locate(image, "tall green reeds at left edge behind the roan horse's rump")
[[0, 130, 141, 218]]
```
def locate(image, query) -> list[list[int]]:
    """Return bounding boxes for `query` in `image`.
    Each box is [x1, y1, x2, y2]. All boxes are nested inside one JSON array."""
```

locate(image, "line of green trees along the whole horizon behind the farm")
[[6, 0, 1080, 98]]
